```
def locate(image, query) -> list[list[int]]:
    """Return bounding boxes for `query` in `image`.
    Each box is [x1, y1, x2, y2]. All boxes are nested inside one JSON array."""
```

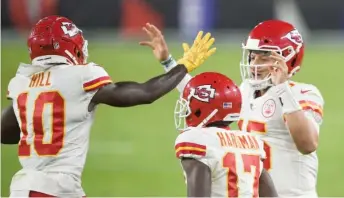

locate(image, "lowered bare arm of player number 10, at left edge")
[[1, 105, 20, 144]]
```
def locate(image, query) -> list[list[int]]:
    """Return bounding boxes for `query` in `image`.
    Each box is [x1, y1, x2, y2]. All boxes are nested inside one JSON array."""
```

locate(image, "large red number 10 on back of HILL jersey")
[[17, 91, 65, 157]]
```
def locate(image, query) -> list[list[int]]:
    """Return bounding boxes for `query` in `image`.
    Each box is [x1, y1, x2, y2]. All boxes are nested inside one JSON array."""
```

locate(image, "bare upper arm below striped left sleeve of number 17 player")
[[182, 158, 211, 197]]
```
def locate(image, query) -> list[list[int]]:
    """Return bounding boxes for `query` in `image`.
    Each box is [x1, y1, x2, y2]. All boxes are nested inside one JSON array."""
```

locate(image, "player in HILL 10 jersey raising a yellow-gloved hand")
[[1, 16, 215, 197]]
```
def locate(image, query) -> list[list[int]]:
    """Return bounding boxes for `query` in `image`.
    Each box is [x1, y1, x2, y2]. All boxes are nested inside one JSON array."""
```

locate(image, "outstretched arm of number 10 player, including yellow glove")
[[91, 27, 216, 107]]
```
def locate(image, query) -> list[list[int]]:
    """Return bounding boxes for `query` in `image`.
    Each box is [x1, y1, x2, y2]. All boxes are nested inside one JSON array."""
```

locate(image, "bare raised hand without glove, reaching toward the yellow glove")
[[139, 23, 169, 62]]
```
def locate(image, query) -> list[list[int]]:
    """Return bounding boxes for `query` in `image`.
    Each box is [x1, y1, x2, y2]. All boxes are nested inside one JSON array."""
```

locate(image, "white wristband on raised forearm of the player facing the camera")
[[274, 82, 302, 114]]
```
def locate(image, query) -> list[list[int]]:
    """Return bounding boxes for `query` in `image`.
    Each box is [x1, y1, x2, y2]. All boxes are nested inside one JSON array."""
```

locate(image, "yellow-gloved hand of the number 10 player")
[[178, 31, 216, 72]]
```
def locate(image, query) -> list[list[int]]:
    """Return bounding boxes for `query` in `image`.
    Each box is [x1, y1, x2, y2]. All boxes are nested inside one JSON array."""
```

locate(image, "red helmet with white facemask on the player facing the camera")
[[240, 20, 304, 90]]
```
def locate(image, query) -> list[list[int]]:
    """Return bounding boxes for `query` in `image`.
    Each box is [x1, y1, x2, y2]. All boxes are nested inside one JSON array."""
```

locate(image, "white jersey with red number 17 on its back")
[[175, 127, 265, 197]]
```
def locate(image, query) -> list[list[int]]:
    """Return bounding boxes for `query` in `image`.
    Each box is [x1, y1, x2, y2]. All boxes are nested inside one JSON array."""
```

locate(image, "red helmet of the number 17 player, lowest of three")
[[174, 72, 241, 130]]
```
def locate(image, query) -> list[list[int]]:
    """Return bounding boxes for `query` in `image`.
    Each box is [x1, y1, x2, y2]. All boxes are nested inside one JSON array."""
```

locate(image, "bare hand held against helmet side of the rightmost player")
[[269, 51, 289, 85]]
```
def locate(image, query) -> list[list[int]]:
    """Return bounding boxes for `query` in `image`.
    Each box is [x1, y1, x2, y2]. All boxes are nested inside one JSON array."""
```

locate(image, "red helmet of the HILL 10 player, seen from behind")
[[27, 16, 88, 65]]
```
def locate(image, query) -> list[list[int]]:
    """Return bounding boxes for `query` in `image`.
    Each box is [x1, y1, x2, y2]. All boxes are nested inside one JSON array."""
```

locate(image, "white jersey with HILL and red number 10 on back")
[[8, 63, 112, 197]]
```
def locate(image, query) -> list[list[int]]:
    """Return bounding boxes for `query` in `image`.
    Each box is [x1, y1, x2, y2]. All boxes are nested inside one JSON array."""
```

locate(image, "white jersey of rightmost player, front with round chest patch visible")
[[238, 81, 324, 197]]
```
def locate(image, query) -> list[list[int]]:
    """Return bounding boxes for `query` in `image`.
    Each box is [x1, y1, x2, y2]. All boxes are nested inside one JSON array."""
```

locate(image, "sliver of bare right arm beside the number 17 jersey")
[[259, 169, 278, 197]]
